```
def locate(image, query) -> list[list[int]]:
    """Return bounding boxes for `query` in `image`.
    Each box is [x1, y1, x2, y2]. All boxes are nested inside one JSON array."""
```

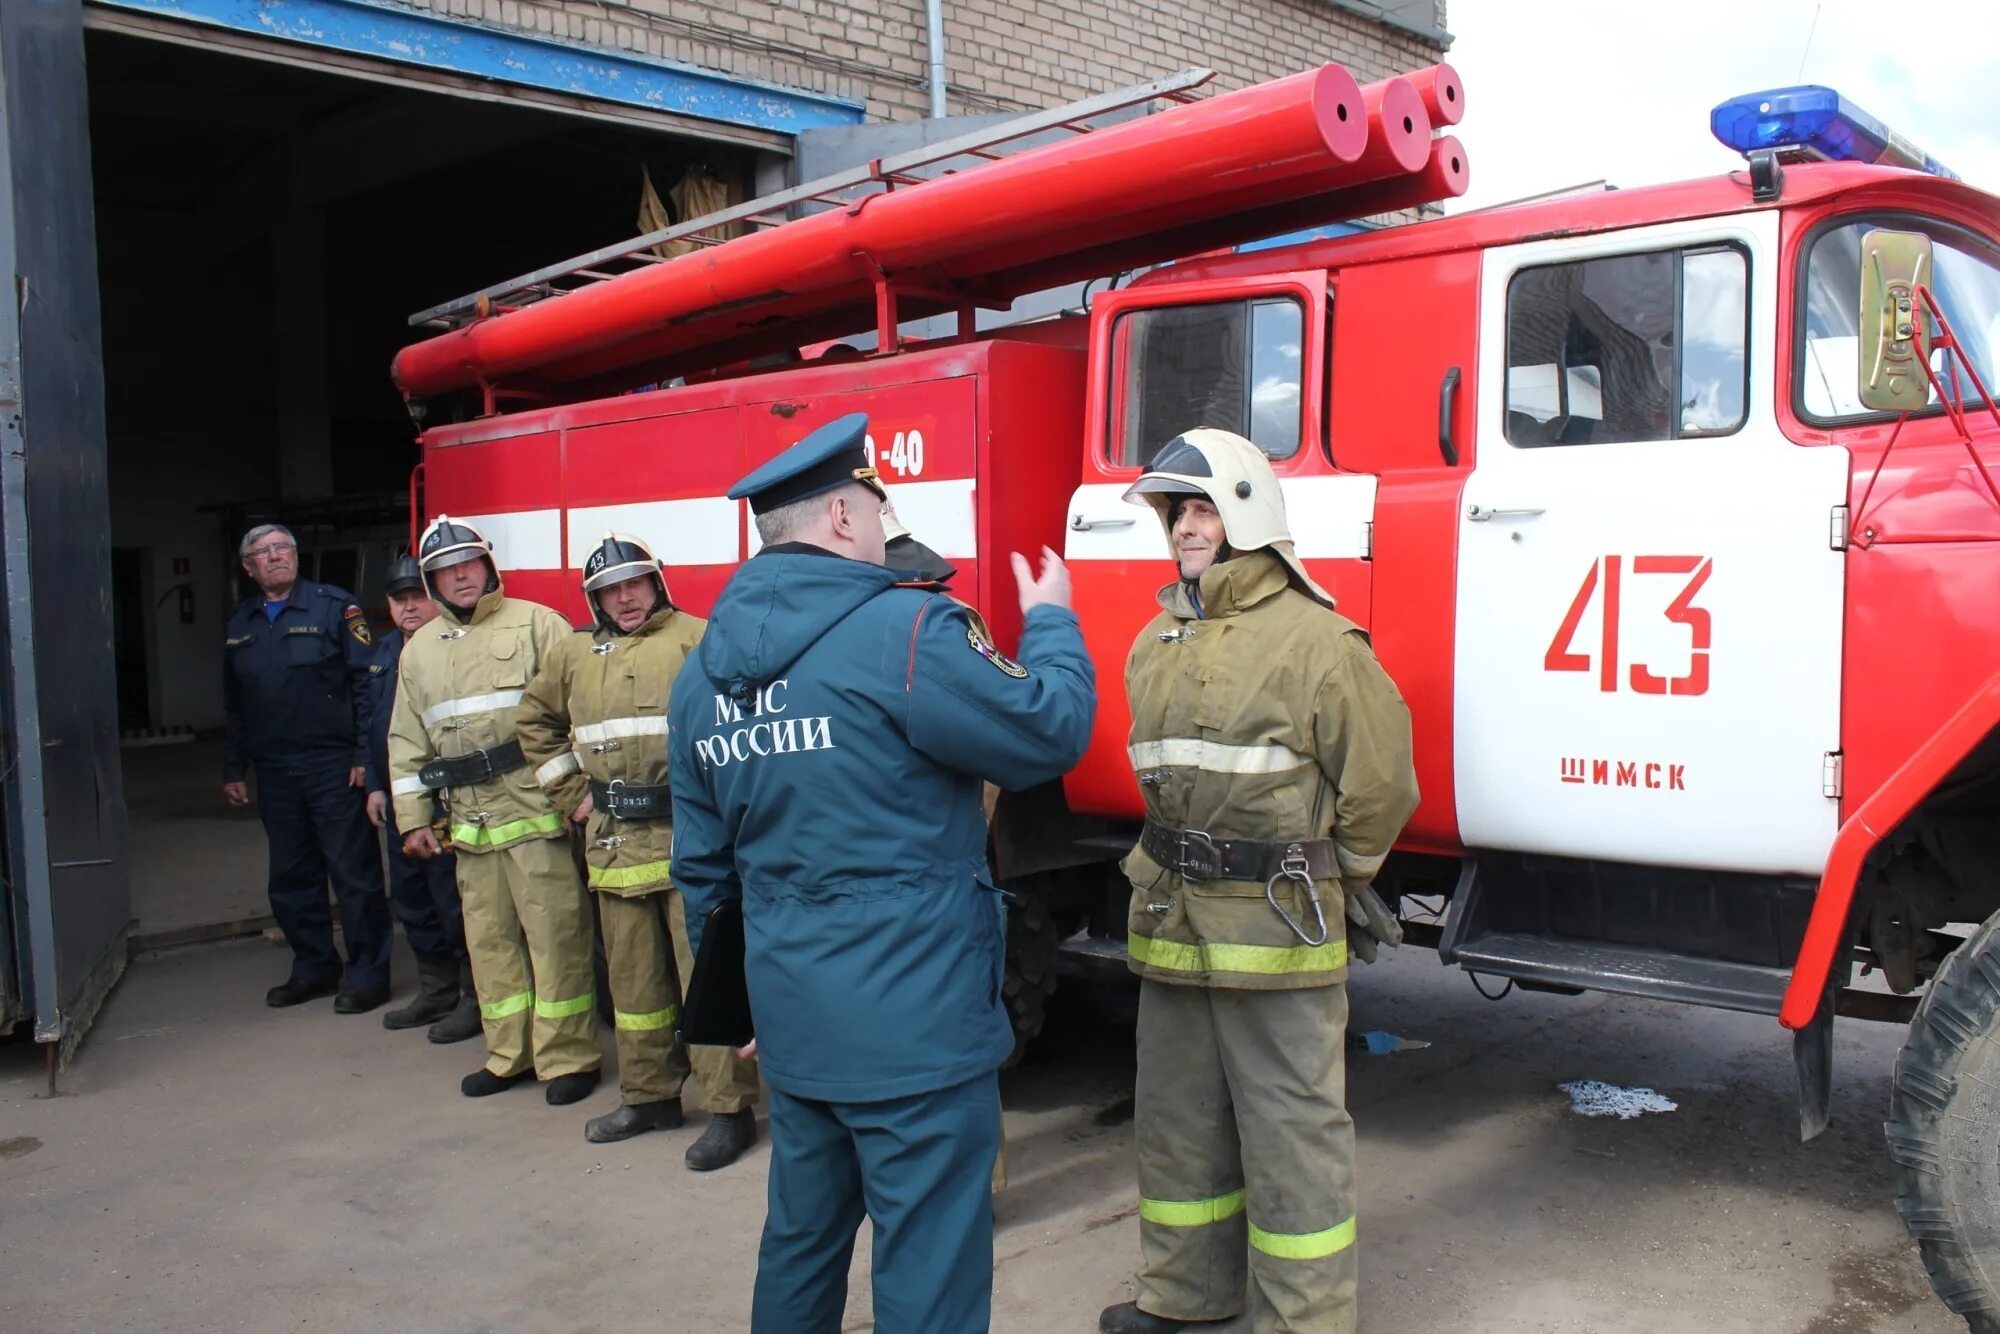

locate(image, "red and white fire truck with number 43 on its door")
[[396, 66, 2000, 1330]]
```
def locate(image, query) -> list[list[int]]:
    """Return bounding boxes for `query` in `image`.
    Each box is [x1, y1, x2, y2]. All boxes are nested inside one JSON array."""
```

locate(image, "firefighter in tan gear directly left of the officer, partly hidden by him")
[[516, 534, 758, 1172]]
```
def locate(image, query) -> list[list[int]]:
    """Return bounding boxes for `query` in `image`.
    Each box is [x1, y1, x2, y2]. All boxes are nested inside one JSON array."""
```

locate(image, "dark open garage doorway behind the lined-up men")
[[86, 30, 770, 946]]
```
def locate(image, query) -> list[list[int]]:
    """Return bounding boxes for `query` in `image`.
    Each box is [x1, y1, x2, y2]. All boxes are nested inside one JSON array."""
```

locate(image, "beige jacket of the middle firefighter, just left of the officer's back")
[[516, 608, 708, 894]]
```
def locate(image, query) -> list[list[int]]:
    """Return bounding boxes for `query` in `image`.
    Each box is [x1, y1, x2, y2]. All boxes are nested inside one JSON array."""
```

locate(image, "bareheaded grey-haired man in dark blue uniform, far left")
[[222, 524, 394, 1014]]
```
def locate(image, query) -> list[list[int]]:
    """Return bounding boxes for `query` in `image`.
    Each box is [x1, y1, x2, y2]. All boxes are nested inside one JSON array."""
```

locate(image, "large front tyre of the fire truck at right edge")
[[1884, 912, 2000, 1334]]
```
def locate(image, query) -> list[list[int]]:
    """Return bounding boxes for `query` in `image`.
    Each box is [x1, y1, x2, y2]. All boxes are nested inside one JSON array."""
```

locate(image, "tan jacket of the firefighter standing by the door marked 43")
[[1124, 550, 1416, 990]]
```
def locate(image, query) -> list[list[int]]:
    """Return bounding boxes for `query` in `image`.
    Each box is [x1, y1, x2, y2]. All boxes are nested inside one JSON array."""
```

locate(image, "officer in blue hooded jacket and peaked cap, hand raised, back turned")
[[668, 416, 1096, 1334]]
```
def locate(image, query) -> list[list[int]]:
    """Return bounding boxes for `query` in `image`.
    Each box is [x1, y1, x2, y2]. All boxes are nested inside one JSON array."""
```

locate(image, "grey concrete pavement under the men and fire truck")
[[0, 940, 1962, 1334]]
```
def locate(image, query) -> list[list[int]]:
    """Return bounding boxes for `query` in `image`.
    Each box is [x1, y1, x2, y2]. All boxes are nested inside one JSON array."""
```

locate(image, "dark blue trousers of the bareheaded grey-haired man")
[[256, 754, 396, 988]]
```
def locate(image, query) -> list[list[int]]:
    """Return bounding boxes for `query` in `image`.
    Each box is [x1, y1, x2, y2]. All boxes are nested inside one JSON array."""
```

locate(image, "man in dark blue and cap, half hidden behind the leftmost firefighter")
[[366, 556, 480, 1042]]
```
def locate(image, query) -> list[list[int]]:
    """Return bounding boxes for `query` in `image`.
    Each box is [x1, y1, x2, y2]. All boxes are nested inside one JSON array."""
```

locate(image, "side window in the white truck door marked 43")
[[1506, 246, 1750, 448]]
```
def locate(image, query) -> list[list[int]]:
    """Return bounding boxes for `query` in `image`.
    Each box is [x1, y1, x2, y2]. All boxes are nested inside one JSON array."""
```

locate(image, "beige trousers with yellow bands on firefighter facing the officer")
[[1134, 982, 1356, 1334]]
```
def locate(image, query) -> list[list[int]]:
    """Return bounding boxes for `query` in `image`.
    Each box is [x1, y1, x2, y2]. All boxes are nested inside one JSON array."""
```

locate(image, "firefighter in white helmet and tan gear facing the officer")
[[1098, 430, 1416, 1334]]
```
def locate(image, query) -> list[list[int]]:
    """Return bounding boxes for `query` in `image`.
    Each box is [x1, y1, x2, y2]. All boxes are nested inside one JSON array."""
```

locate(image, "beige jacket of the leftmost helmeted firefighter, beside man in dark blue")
[[388, 590, 572, 852]]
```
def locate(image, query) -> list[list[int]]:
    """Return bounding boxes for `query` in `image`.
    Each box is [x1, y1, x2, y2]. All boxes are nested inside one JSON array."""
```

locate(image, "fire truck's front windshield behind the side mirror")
[[1794, 216, 2000, 422]]
